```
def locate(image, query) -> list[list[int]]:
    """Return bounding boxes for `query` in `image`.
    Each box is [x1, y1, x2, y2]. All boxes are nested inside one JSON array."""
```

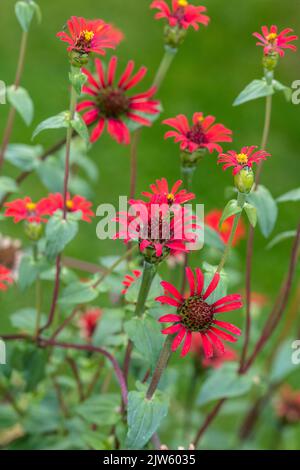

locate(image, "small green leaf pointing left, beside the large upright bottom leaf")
[[76, 394, 121, 427]]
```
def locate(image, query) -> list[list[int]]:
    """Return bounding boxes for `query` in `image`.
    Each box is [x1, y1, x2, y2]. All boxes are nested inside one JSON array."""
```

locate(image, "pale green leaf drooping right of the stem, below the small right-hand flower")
[[247, 185, 278, 238]]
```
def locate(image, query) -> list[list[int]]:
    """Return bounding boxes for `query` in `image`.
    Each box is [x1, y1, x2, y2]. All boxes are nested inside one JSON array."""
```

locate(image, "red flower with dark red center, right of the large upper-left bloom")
[[164, 113, 232, 153]]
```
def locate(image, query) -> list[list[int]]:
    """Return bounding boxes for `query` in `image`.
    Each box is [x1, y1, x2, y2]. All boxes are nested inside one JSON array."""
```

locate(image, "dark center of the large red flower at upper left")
[[96, 88, 129, 118]]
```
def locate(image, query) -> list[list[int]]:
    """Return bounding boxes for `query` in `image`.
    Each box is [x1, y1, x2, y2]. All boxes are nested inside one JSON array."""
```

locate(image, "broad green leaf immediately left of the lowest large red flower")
[[124, 315, 164, 368]]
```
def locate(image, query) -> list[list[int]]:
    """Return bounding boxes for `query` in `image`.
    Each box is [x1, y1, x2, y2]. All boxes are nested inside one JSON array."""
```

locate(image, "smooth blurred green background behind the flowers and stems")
[[0, 0, 300, 327]]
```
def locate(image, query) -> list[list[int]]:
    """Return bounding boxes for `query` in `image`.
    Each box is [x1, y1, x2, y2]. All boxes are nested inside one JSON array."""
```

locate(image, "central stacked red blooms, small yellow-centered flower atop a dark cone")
[[115, 178, 200, 260]]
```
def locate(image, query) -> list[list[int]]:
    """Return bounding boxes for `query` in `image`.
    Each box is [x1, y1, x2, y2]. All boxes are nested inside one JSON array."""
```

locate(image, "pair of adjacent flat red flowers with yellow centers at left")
[[4, 193, 94, 224]]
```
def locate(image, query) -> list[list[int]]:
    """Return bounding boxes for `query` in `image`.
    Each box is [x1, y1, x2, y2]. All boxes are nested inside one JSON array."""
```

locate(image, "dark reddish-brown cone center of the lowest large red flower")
[[178, 296, 214, 332]]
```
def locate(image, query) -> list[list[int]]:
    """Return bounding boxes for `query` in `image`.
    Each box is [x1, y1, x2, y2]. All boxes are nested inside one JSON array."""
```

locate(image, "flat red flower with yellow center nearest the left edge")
[[4, 197, 52, 223]]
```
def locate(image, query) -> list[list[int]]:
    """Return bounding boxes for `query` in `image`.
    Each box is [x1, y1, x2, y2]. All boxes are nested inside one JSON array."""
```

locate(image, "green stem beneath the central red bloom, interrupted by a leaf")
[[123, 261, 156, 380]]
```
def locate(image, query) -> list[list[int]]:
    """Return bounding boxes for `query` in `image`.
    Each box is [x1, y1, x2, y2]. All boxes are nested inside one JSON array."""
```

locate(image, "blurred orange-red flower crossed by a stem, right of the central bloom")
[[205, 209, 246, 246]]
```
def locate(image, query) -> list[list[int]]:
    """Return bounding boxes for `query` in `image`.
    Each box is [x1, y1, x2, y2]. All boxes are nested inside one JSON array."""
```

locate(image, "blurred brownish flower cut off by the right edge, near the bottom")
[[275, 385, 300, 423]]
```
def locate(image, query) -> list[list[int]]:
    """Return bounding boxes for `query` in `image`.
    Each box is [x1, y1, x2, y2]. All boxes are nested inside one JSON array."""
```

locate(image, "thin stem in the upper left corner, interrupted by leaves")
[[0, 31, 28, 169]]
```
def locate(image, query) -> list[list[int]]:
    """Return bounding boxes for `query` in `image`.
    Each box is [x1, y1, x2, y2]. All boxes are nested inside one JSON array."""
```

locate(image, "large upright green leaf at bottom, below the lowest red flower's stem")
[[126, 388, 169, 450]]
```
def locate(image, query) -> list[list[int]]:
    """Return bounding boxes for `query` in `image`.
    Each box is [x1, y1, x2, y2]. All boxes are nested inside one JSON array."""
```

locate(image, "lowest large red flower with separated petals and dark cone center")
[[156, 268, 242, 358]]
